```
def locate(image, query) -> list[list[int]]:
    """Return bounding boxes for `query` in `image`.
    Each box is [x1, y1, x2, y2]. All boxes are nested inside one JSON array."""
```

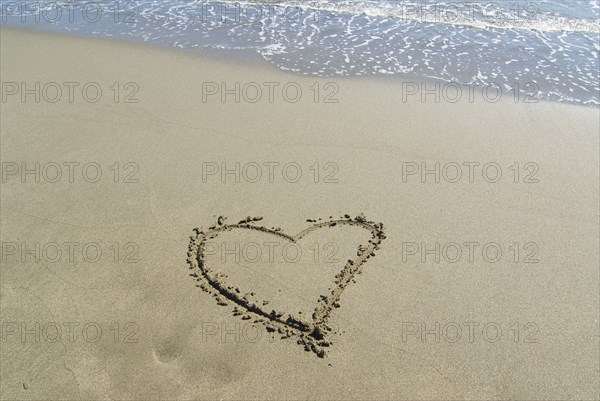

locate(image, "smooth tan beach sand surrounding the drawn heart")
[[0, 28, 600, 400]]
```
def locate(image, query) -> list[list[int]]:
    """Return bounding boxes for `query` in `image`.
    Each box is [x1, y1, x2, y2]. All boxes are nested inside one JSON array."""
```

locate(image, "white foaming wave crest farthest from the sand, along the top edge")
[[0, 0, 600, 33]]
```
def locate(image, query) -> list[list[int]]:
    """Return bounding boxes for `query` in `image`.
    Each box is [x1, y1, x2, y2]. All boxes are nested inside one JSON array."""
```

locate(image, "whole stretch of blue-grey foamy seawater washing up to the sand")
[[0, 0, 600, 105]]
